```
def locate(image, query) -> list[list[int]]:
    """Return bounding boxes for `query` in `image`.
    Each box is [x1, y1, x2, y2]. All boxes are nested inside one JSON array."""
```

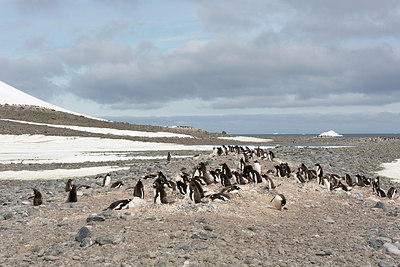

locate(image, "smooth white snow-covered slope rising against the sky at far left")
[[0, 81, 89, 117]]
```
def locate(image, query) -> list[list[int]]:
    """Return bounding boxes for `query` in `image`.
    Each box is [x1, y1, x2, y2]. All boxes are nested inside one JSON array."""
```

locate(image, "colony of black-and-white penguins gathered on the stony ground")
[[30, 146, 398, 213]]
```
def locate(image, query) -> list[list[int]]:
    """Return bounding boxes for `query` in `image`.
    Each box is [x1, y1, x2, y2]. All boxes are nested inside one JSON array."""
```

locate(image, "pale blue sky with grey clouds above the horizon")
[[0, 0, 400, 134]]
